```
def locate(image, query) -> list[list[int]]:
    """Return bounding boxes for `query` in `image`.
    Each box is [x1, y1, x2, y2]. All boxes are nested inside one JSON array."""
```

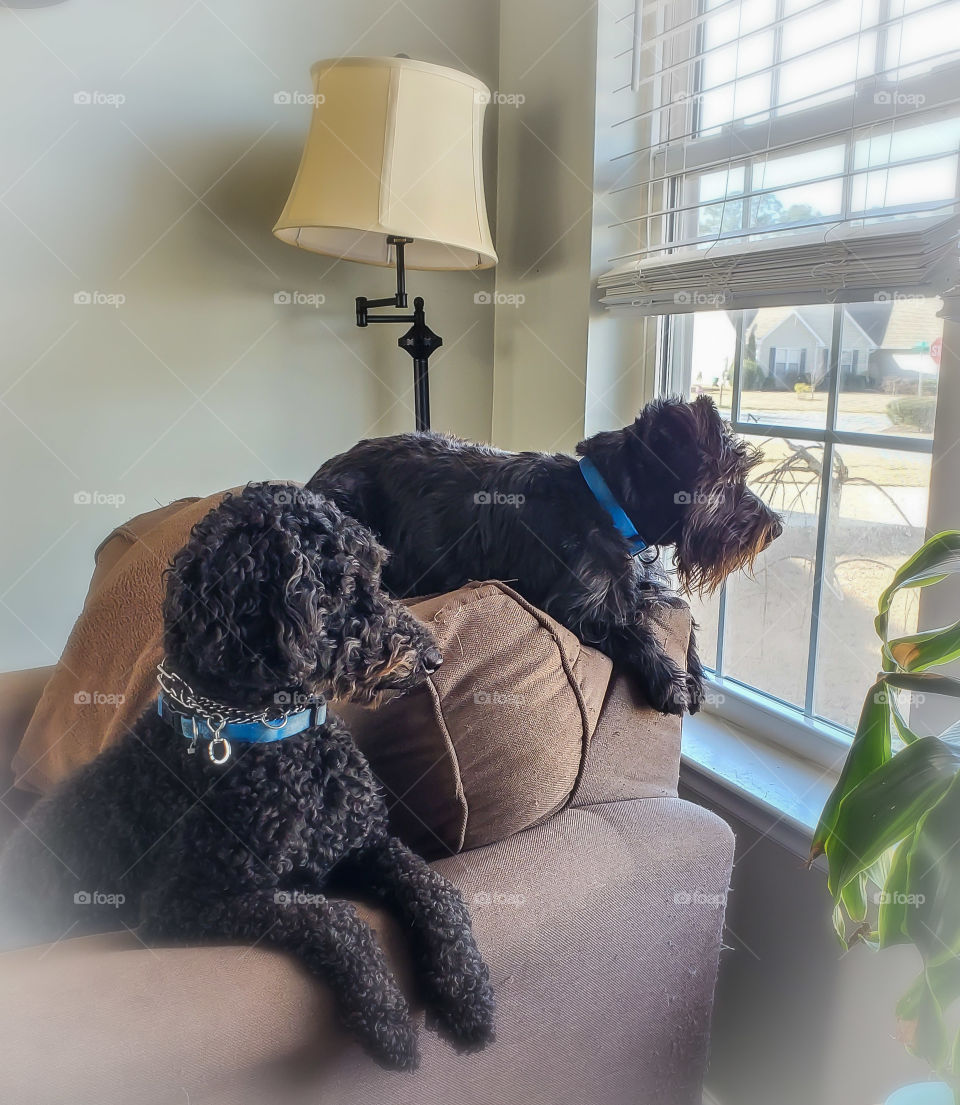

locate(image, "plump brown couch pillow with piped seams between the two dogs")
[[337, 582, 612, 857]]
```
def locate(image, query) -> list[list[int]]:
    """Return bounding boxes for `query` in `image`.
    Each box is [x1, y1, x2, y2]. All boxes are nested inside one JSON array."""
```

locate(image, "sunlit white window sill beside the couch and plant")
[[681, 711, 845, 860]]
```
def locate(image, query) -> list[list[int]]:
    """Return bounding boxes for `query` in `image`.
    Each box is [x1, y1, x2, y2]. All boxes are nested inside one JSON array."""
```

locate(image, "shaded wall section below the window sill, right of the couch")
[[684, 791, 927, 1105]]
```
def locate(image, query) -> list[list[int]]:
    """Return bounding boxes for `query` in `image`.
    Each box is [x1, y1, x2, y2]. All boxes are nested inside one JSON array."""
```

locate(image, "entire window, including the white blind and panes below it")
[[598, 0, 960, 749]]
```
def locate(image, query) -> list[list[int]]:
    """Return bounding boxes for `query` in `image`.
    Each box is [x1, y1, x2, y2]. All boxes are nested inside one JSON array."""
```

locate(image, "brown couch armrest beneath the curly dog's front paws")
[[0, 798, 732, 1105]]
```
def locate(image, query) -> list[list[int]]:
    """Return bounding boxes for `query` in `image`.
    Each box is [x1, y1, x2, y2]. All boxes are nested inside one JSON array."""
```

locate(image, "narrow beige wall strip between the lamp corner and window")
[[493, 0, 597, 450]]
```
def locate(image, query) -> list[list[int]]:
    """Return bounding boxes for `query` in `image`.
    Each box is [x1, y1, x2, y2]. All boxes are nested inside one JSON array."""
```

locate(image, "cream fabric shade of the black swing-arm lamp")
[[273, 57, 497, 270]]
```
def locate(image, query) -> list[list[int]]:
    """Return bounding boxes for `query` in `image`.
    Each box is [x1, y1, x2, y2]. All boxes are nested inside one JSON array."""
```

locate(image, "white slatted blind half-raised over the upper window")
[[599, 0, 960, 314]]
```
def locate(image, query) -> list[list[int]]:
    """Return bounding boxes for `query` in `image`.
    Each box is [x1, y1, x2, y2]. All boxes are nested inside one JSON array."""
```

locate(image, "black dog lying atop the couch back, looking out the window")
[[307, 397, 781, 714]]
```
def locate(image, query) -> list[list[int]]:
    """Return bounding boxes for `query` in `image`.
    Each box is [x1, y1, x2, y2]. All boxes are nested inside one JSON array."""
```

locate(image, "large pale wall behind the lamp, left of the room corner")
[[0, 0, 499, 670]]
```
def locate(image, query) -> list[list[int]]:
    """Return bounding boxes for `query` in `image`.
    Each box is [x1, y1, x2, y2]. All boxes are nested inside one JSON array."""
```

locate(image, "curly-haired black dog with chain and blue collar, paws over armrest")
[[0, 484, 493, 1067]]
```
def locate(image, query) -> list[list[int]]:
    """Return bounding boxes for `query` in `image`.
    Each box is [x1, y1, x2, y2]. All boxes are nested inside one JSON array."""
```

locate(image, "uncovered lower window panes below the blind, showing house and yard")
[[661, 297, 943, 728]]
